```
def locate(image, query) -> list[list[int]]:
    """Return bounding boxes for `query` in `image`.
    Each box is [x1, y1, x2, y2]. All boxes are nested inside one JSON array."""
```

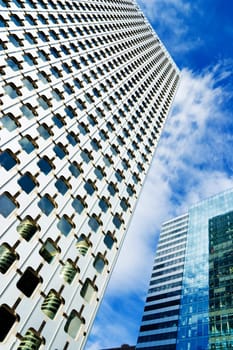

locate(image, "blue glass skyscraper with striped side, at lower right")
[[136, 190, 233, 350]]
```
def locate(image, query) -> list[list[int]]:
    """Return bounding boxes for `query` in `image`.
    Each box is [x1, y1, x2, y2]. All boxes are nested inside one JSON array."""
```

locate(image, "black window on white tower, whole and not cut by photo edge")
[[16, 267, 42, 298]]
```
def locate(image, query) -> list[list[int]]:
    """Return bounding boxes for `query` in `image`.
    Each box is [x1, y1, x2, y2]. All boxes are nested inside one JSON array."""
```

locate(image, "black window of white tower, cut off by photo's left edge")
[[0, 304, 19, 342]]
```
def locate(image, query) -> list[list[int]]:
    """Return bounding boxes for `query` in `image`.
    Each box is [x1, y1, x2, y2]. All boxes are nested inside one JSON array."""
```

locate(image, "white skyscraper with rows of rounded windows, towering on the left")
[[0, 0, 179, 350]]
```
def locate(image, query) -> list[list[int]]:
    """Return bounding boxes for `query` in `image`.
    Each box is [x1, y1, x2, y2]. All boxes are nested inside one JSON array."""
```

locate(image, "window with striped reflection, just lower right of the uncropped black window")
[[41, 289, 62, 320]]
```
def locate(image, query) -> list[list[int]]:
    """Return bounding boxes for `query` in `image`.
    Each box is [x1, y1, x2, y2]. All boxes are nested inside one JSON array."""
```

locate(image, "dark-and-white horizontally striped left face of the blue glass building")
[[137, 215, 188, 349]]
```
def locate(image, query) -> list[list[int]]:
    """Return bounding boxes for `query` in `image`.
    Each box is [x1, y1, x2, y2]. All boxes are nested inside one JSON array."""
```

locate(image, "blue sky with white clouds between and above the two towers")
[[85, 0, 233, 350]]
